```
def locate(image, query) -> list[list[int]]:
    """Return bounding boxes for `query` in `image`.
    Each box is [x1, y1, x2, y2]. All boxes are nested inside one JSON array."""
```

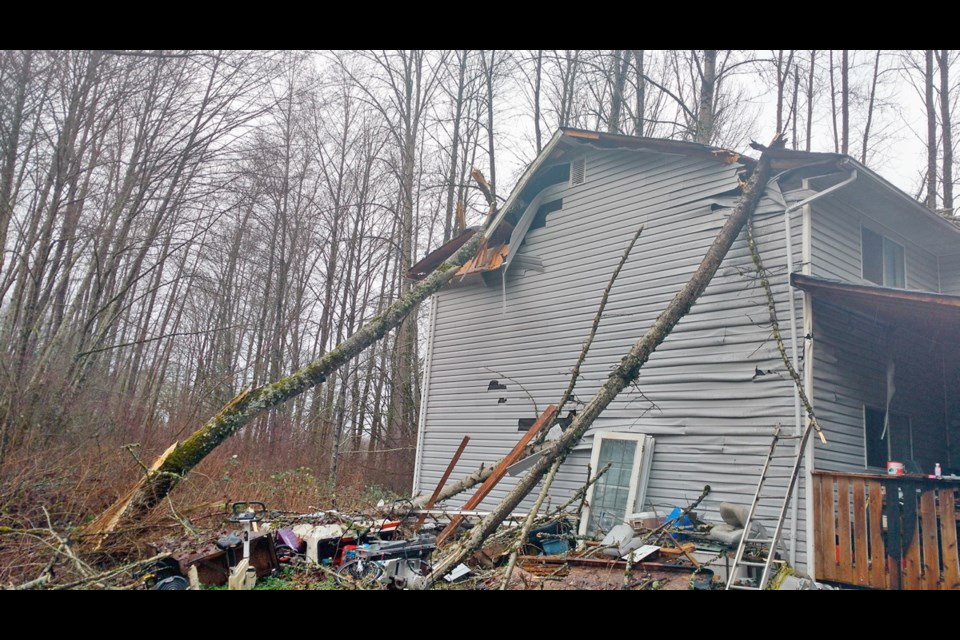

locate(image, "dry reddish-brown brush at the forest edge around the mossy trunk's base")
[[0, 435, 409, 586]]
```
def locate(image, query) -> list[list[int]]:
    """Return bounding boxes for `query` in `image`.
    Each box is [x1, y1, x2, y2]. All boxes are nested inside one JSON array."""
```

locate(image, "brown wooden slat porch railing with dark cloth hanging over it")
[[813, 471, 960, 590]]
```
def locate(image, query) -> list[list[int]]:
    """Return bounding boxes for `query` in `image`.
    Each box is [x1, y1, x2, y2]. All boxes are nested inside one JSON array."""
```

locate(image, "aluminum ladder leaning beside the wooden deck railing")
[[727, 421, 813, 591]]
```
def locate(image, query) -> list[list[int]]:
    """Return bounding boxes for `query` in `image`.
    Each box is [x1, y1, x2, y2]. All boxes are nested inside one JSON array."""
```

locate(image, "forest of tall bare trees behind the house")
[[0, 50, 958, 516]]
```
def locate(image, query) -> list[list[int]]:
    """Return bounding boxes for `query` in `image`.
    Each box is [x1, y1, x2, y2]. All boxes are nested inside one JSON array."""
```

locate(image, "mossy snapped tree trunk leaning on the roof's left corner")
[[81, 221, 493, 548]]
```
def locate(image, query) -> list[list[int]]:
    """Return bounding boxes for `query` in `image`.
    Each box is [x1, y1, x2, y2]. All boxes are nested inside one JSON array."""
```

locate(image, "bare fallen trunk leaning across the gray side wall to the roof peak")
[[424, 134, 783, 588]]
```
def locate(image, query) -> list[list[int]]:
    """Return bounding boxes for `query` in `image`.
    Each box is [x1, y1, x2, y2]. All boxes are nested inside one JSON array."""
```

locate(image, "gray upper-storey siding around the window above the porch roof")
[[812, 196, 940, 292]]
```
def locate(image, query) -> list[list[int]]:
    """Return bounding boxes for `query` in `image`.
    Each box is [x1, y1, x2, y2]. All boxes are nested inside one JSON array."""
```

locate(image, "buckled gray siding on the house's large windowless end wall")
[[417, 151, 804, 563]]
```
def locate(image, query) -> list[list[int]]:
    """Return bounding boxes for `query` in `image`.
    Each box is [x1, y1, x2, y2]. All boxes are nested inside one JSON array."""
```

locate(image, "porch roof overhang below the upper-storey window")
[[790, 273, 960, 344]]
